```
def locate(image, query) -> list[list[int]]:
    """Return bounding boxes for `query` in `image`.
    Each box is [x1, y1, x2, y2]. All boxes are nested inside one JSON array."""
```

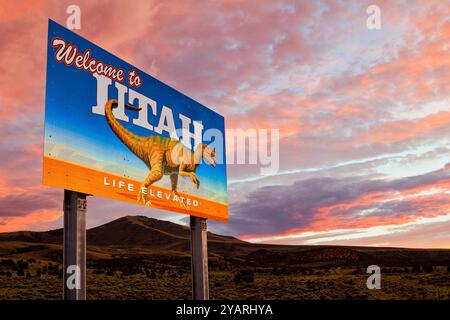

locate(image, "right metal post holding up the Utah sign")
[[191, 216, 209, 300]]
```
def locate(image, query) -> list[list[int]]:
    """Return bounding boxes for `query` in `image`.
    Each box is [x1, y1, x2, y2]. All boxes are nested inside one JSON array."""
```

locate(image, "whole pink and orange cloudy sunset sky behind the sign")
[[0, 0, 450, 248]]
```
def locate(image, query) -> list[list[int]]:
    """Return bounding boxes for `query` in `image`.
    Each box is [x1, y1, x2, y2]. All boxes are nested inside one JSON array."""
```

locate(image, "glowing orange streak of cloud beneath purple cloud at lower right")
[[240, 179, 450, 239]]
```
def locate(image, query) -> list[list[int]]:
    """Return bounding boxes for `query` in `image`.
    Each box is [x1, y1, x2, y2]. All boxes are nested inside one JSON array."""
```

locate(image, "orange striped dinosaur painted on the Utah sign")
[[105, 99, 217, 208]]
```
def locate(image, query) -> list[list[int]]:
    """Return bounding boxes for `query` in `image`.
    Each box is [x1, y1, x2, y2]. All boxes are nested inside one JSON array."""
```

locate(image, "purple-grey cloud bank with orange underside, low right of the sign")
[[214, 165, 450, 238]]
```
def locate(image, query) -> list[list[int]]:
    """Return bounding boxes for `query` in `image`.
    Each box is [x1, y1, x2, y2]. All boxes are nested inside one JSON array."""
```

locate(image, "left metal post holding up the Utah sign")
[[63, 190, 86, 300]]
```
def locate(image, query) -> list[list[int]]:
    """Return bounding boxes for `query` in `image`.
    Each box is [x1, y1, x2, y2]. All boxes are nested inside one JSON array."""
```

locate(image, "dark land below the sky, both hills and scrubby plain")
[[0, 216, 450, 299]]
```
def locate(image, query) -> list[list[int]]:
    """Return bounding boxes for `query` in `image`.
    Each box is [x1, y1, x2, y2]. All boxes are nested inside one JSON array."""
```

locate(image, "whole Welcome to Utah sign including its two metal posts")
[[43, 20, 228, 299]]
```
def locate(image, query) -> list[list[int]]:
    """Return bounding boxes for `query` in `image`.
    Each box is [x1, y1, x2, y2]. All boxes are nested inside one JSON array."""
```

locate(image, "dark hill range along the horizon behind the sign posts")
[[0, 216, 450, 268]]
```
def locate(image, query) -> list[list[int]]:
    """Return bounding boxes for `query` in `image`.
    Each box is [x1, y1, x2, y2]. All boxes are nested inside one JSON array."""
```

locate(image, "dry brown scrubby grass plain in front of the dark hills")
[[0, 260, 450, 299]]
